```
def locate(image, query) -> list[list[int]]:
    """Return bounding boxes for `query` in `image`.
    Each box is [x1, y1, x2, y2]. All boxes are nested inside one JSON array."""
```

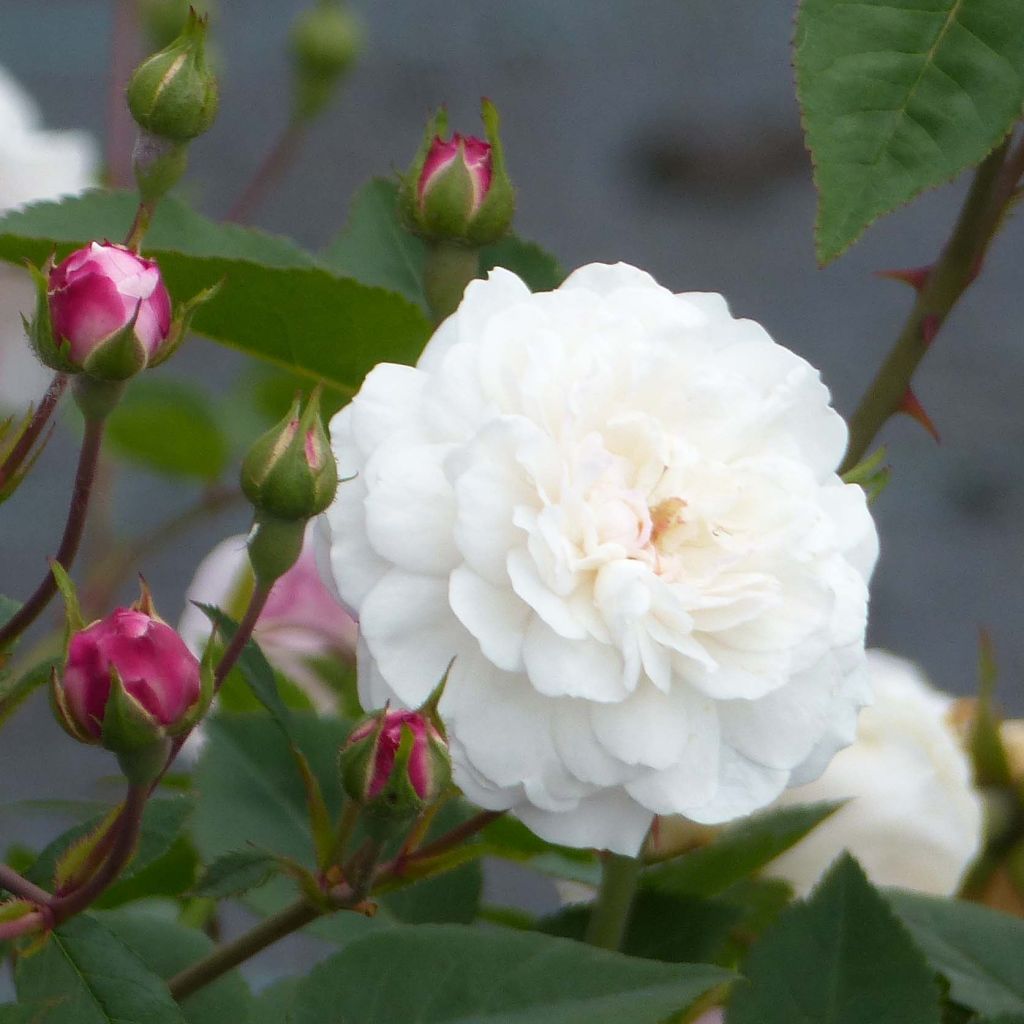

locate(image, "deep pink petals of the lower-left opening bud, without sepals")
[[55, 608, 203, 749]]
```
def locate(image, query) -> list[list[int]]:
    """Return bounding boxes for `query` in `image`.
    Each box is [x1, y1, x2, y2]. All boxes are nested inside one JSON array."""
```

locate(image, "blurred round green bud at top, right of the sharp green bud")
[[292, 0, 362, 119]]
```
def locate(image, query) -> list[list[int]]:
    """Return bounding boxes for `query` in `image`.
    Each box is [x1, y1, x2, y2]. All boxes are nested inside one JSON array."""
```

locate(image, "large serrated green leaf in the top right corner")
[[796, 0, 1024, 263]]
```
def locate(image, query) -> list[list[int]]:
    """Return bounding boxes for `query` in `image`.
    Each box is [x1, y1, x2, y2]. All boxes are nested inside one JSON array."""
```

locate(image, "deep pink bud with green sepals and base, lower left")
[[51, 569, 213, 785]]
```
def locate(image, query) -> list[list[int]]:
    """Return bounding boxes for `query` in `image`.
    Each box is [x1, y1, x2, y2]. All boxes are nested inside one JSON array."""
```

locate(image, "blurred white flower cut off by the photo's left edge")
[[0, 68, 98, 414]]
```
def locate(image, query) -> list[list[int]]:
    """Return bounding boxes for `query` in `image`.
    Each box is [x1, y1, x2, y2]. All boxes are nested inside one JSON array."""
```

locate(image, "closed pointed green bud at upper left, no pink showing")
[[128, 8, 217, 142]]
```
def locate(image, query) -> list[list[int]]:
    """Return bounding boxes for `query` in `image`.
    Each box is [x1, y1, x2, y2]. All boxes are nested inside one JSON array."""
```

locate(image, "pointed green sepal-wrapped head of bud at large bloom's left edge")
[[242, 391, 338, 524]]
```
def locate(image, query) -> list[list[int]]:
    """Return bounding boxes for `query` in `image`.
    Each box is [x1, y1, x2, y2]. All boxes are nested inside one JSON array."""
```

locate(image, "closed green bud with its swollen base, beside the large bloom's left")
[[242, 388, 338, 587]]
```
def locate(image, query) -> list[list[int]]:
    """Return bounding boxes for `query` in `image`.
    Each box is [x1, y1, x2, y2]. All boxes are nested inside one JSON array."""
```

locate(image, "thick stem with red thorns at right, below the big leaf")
[[839, 134, 1024, 473]]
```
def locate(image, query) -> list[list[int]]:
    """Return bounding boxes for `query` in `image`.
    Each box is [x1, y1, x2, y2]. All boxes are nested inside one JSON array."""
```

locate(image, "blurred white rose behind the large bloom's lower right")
[[767, 650, 983, 896]]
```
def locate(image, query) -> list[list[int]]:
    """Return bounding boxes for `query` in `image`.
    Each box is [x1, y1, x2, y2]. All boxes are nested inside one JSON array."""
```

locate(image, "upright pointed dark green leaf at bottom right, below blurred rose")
[[727, 854, 940, 1024]]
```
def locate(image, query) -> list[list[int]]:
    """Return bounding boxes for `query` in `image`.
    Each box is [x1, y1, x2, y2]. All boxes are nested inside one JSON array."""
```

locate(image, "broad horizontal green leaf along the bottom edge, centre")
[[292, 925, 735, 1024]]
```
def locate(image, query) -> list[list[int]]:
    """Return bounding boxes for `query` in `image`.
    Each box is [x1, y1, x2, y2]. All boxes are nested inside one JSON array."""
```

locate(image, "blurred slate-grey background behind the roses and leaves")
[[0, 0, 1024, 991]]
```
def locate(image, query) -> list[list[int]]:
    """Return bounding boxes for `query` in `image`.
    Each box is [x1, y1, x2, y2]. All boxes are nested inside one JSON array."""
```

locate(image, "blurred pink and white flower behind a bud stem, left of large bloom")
[[178, 529, 356, 711]]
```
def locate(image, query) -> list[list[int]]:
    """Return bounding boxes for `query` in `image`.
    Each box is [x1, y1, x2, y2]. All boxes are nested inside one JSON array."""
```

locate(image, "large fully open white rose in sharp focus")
[[324, 264, 877, 854]]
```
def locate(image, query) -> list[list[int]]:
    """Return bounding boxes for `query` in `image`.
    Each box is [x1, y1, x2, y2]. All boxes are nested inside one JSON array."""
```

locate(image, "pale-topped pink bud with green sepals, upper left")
[[29, 242, 172, 381]]
